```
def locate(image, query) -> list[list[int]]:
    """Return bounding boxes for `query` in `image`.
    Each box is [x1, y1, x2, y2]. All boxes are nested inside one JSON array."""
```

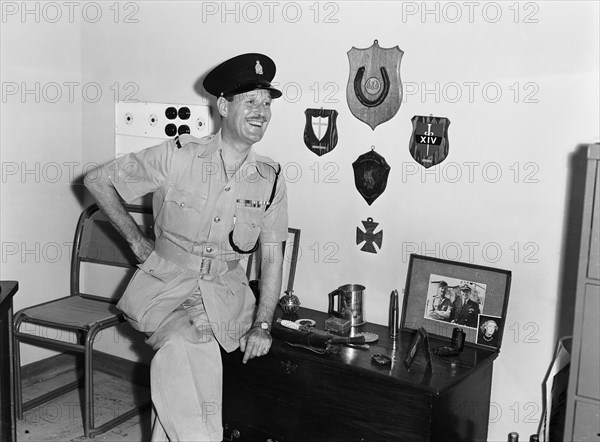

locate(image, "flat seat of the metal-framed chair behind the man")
[[23, 296, 122, 329]]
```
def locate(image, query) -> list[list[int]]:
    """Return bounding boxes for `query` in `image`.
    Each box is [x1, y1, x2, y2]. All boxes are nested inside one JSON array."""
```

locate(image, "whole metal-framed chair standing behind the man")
[[13, 204, 153, 440]]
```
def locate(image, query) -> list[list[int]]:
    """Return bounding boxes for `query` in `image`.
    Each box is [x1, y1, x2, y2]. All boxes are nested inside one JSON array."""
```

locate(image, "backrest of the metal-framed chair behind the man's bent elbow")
[[71, 204, 153, 302]]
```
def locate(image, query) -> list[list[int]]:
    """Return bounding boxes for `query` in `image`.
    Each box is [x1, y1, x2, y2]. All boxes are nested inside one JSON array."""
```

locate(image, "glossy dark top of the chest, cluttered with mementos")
[[272, 308, 498, 394]]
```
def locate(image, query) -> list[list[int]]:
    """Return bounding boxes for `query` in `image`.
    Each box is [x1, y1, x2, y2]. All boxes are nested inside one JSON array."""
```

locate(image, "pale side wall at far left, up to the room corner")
[[0, 2, 83, 363]]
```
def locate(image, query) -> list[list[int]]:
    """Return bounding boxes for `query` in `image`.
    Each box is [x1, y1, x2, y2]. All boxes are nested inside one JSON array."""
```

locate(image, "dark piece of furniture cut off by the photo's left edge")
[[0, 281, 19, 442]]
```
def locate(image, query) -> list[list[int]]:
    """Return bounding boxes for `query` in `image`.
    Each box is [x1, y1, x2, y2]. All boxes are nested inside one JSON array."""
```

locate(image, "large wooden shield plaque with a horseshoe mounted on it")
[[346, 40, 404, 130]]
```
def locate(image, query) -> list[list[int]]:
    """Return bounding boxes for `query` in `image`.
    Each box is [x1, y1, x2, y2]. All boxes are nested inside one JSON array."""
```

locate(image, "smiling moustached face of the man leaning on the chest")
[[217, 89, 272, 145]]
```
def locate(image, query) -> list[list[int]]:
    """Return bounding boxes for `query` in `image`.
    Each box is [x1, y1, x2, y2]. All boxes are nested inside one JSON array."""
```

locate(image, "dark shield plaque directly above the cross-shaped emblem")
[[352, 147, 390, 206]]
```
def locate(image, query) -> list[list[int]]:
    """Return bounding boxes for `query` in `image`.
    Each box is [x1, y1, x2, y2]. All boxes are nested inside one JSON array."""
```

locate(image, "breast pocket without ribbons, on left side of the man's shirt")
[[158, 184, 207, 240]]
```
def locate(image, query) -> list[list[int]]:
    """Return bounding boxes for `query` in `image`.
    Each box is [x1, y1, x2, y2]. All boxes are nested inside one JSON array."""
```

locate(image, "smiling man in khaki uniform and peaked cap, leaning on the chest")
[[84, 54, 288, 441]]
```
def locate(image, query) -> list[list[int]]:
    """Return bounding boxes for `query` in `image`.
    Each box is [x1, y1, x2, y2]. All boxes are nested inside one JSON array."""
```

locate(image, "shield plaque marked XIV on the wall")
[[409, 115, 450, 169]]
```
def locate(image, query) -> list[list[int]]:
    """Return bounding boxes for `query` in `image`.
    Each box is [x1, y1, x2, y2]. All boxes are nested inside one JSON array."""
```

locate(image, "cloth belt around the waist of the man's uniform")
[[154, 238, 240, 281]]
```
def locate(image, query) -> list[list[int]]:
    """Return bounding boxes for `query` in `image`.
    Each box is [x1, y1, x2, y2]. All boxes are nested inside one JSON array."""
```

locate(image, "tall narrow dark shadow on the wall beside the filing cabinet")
[[555, 144, 587, 339]]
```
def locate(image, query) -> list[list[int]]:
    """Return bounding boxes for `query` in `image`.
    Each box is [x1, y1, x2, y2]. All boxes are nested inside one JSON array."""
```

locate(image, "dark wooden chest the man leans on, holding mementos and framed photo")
[[223, 308, 497, 442]]
